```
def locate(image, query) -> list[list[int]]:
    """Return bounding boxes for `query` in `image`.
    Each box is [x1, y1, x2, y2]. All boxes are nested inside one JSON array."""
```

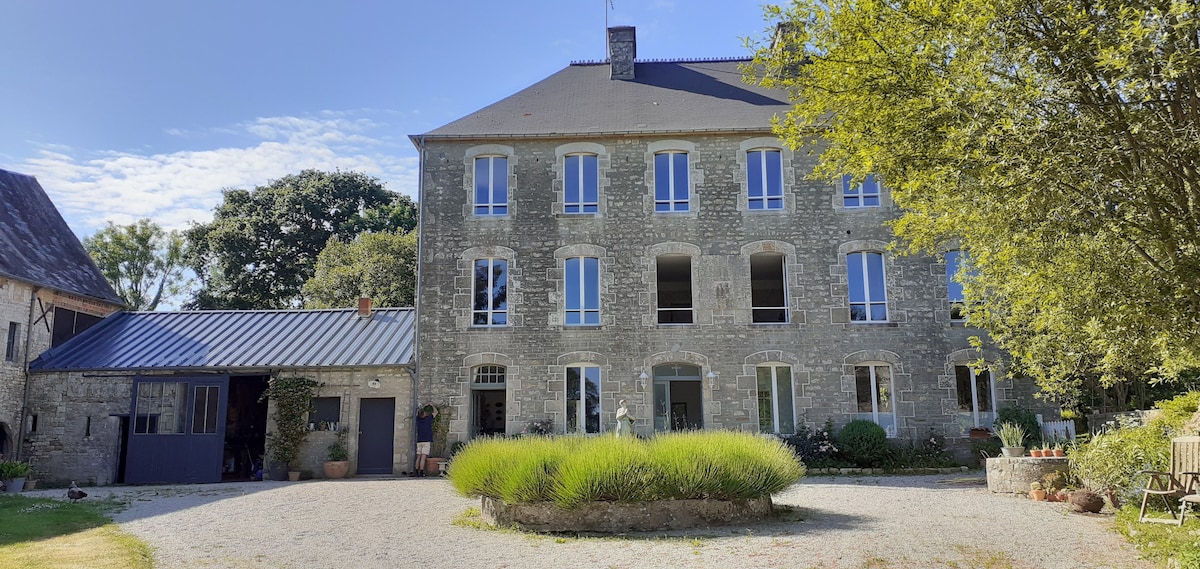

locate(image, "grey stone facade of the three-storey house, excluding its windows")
[[419, 130, 1056, 444]]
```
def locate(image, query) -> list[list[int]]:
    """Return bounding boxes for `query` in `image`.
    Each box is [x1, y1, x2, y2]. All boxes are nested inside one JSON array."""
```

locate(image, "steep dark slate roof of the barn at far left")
[[0, 169, 124, 305]]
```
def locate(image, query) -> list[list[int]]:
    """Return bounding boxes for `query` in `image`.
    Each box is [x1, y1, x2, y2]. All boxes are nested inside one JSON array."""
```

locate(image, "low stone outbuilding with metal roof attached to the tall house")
[[26, 299, 415, 485]]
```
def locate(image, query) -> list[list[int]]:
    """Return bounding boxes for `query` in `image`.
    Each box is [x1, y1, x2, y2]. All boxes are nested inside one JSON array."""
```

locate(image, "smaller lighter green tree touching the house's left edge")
[[304, 232, 416, 309]]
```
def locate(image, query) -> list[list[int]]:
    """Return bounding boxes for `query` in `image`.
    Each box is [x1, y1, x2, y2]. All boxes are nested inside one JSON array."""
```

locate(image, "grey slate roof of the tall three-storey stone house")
[[410, 59, 791, 139]]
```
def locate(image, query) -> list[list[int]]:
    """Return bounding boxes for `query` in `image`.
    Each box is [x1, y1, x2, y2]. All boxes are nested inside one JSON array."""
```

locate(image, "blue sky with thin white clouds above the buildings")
[[0, 0, 767, 236]]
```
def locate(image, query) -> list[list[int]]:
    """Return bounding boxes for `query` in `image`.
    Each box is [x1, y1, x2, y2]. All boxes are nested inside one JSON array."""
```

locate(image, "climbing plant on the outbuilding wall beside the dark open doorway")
[[263, 377, 320, 480]]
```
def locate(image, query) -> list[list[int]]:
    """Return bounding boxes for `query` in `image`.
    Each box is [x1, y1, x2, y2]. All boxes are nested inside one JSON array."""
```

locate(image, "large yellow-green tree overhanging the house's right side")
[[748, 0, 1200, 395]]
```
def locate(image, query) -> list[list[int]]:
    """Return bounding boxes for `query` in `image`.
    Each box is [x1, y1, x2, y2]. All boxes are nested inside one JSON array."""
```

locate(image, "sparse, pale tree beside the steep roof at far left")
[[83, 218, 190, 310]]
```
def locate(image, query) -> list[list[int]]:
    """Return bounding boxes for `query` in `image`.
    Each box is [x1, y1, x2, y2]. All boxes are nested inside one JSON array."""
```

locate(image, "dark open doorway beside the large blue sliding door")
[[221, 376, 268, 480]]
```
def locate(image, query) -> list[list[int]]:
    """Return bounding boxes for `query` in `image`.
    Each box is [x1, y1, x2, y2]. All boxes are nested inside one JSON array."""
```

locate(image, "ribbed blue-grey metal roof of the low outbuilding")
[[29, 309, 416, 372]]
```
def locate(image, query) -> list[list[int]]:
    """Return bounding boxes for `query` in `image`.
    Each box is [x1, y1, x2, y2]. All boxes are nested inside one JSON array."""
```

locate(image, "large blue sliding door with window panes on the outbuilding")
[[125, 376, 229, 484]]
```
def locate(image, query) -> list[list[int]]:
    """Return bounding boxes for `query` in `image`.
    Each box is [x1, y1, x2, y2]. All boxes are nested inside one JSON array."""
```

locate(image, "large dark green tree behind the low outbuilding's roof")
[[186, 169, 416, 309]]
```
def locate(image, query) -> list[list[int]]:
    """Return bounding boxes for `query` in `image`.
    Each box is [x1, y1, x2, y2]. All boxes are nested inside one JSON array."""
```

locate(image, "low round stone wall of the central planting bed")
[[482, 496, 772, 533]]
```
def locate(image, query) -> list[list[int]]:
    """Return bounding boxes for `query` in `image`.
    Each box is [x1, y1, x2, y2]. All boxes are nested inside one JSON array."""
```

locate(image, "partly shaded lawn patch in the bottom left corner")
[[0, 496, 154, 569]]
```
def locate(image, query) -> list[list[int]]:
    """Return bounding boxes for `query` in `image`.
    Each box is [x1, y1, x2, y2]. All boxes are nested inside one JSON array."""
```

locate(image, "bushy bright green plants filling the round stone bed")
[[449, 431, 804, 509]]
